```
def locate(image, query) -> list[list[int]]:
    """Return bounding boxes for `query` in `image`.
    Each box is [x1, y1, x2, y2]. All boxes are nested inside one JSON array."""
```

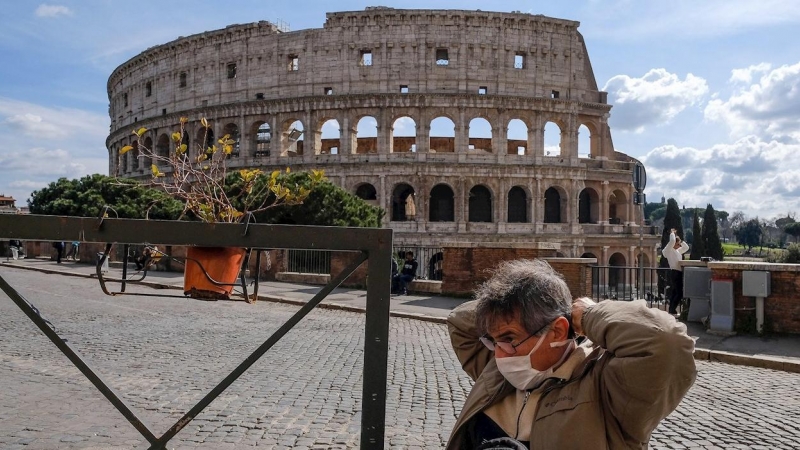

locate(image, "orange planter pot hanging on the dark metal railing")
[[183, 247, 245, 300]]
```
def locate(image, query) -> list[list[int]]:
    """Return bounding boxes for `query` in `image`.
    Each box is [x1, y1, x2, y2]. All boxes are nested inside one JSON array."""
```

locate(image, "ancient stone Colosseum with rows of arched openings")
[[107, 7, 659, 278]]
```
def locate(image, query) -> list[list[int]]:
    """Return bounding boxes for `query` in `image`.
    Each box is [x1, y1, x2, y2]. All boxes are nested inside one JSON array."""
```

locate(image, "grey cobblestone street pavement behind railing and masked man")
[[0, 268, 800, 449]]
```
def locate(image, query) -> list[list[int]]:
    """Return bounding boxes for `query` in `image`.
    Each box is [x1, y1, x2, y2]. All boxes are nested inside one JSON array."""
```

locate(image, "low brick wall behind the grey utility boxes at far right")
[[711, 267, 800, 334]]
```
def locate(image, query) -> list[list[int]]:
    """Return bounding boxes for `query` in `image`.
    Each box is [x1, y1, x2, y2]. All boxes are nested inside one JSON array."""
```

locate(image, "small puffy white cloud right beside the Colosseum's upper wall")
[[603, 69, 708, 133]]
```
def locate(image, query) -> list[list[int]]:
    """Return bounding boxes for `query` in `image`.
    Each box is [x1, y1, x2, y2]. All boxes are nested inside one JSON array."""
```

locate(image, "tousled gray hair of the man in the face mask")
[[475, 259, 572, 334]]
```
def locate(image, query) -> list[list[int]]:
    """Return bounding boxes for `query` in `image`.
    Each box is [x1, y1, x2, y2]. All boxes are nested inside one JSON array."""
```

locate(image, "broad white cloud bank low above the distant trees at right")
[[641, 135, 800, 216]]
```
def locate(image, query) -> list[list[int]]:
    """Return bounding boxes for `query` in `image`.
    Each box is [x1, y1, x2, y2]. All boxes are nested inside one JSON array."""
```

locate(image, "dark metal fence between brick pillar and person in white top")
[[588, 266, 670, 311]]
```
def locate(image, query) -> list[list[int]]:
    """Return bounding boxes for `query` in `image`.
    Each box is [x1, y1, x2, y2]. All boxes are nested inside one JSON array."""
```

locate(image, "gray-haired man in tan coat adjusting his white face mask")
[[447, 260, 696, 450]]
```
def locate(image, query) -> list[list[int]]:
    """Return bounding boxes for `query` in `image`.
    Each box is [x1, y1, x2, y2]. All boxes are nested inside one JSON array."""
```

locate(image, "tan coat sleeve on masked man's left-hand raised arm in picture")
[[447, 300, 494, 381]]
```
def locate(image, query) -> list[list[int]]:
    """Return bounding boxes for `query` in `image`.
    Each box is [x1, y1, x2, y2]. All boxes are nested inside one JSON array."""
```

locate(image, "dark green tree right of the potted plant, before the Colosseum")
[[226, 173, 384, 228]]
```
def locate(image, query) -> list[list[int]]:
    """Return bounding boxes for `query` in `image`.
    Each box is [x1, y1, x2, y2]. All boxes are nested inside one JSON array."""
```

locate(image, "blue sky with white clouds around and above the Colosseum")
[[0, 0, 800, 219]]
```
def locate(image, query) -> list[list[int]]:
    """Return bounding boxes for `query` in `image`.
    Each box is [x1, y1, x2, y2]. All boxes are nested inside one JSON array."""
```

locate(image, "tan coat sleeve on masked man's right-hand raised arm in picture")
[[583, 301, 697, 442]]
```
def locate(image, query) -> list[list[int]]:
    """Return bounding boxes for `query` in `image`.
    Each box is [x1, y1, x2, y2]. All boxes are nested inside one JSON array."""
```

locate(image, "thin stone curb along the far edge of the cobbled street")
[[0, 261, 800, 373]]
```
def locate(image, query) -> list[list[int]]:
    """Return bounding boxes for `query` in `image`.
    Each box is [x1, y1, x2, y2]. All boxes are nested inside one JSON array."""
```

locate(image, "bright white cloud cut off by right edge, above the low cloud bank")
[[705, 62, 800, 140]]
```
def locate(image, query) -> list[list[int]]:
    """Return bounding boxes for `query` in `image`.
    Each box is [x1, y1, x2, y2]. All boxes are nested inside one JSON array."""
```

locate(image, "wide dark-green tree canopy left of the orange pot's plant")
[[28, 174, 183, 220]]
